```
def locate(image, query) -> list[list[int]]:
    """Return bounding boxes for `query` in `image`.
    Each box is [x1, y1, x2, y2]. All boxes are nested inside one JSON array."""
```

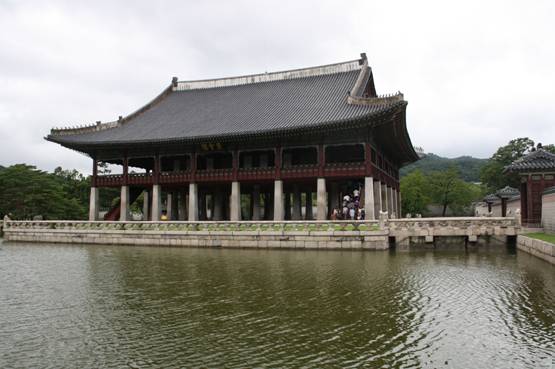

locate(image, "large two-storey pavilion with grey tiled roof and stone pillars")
[[46, 54, 418, 221]]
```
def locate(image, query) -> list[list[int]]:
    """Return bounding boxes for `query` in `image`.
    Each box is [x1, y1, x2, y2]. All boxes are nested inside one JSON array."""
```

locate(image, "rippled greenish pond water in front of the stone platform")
[[0, 240, 555, 368]]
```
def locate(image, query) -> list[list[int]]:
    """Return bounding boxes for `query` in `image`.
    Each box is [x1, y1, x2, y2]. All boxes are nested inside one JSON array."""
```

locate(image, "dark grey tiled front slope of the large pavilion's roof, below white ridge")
[[48, 68, 400, 144]]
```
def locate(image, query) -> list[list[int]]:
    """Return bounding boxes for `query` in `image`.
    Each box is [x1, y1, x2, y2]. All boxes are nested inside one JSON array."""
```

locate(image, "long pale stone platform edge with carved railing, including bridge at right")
[[3, 217, 519, 249]]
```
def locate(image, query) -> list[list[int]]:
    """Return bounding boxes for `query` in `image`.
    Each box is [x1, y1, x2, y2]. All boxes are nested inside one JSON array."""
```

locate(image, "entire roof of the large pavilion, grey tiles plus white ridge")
[[46, 54, 417, 161]]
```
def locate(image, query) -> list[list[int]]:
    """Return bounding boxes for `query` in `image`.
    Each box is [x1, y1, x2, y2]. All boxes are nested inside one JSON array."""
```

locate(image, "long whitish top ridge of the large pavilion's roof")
[[173, 53, 366, 91]]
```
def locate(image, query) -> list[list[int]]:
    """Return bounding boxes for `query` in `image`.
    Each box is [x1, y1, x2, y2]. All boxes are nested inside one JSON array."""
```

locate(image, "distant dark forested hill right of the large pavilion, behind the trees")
[[401, 153, 488, 182]]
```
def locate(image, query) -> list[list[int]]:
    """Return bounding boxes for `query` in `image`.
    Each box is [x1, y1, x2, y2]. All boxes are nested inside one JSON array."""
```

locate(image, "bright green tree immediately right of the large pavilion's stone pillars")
[[401, 169, 431, 214]]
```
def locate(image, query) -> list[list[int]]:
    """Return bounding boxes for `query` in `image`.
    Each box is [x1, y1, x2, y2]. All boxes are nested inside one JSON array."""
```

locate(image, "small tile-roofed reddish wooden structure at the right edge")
[[505, 144, 555, 227]]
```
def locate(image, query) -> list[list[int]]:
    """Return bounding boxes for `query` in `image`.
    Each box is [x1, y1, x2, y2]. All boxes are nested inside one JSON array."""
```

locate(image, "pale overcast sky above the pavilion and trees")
[[0, 0, 555, 172]]
